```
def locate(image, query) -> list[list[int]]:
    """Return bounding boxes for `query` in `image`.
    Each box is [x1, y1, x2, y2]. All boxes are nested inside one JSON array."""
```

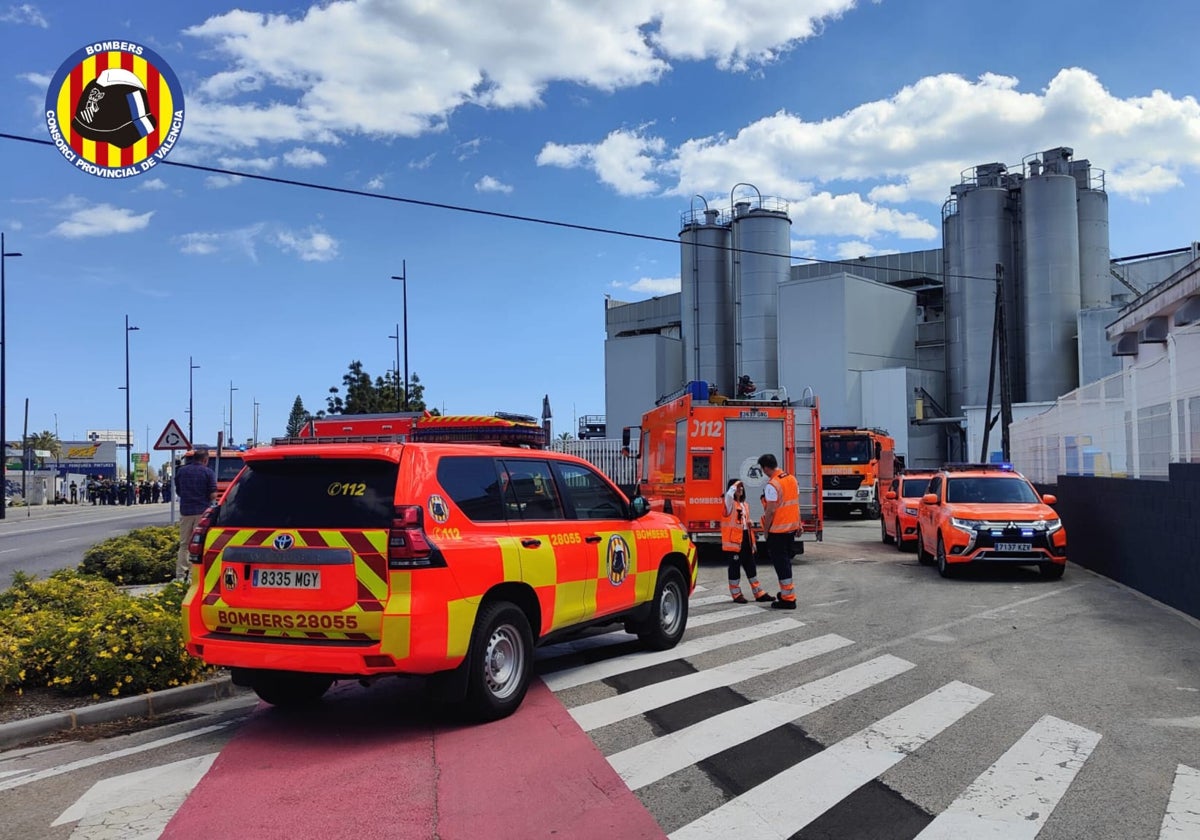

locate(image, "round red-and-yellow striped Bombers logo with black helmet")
[[46, 41, 184, 178]]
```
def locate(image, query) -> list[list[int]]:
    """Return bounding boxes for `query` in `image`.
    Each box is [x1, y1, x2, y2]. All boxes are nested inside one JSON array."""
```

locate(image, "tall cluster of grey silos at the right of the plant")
[[942, 148, 1111, 414]]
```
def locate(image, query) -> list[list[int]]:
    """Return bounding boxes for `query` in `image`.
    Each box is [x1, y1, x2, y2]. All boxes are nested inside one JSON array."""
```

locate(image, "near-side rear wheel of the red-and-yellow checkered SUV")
[[467, 601, 533, 721]]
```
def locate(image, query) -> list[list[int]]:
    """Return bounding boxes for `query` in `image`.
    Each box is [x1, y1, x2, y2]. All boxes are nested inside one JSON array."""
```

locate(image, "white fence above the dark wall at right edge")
[[1009, 324, 1200, 484]]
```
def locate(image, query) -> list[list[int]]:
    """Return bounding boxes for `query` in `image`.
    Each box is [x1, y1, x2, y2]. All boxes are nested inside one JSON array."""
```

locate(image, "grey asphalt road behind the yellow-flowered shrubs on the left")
[[0, 504, 179, 586]]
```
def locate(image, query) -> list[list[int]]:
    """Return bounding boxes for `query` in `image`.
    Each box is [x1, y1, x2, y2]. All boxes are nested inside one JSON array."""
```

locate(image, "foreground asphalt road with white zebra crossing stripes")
[[0, 521, 1200, 840]]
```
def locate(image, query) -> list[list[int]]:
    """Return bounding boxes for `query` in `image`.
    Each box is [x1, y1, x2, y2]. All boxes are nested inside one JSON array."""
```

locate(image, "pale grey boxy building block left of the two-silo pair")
[[604, 335, 683, 438]]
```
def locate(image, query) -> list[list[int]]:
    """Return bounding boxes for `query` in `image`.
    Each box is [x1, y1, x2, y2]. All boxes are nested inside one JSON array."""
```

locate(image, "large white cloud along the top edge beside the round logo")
[[185, 0, 856, 146]]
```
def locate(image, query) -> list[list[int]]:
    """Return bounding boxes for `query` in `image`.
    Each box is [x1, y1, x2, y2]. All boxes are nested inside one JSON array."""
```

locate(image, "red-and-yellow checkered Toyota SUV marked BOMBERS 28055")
[[184, 438, 697, 720]]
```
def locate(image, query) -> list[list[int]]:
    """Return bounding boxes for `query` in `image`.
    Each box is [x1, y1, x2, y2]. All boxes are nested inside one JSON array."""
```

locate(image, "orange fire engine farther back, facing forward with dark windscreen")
[[821, 426, 904, 520]]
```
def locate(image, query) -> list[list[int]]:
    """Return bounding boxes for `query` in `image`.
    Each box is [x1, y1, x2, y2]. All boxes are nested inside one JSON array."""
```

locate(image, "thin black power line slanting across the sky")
[[0, 132, 995, 282]]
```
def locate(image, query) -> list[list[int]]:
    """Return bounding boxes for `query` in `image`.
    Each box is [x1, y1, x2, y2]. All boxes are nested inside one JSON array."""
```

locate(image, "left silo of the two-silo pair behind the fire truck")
[[679, 206, 734, 395]]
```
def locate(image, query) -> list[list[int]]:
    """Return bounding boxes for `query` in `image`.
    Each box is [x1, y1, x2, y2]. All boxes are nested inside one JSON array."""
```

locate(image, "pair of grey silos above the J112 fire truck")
[[679, 184, 792, 396]]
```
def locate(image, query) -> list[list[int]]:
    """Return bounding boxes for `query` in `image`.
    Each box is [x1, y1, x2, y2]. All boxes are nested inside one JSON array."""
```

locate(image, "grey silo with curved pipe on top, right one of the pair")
[[732, 192, 799, 390]]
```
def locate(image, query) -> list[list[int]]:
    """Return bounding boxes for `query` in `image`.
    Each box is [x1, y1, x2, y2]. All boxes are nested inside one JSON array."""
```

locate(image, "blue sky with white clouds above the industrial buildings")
[[0, 0, 1200, 449]]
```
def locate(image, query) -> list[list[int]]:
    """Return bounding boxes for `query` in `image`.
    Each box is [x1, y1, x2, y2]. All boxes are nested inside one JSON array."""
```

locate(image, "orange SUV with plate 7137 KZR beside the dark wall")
[[917, 464, 1067, 580]]
